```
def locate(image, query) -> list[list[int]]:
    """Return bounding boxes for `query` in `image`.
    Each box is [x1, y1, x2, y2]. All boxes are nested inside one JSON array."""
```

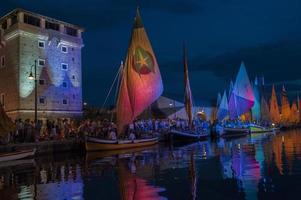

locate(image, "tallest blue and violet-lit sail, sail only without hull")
[[229, 62, 254, 119]]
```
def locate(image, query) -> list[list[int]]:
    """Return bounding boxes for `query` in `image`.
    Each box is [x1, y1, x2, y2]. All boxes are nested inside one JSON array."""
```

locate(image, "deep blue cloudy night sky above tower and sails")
[[0, 0, 301, 106]]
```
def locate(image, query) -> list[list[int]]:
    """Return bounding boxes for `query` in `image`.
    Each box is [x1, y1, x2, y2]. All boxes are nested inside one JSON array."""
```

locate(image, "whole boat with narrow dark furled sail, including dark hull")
[[170, 47, 209, 140]]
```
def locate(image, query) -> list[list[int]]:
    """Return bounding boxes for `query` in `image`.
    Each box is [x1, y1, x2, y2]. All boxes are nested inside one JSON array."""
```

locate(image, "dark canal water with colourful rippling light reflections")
[[0, 131, 301, 200]]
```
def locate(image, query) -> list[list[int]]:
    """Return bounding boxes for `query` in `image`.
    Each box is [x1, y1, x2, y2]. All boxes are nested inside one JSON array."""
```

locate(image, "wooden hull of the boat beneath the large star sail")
[[86, 137, 158, 151]]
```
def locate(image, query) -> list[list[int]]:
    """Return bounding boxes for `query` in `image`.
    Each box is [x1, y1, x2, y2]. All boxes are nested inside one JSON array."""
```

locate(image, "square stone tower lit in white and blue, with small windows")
[[0, 9, 83, 119]]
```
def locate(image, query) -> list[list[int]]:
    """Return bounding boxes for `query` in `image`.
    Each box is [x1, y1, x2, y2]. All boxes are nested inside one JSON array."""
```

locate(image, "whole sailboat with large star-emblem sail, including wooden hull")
[[86, 8, 163, 151]]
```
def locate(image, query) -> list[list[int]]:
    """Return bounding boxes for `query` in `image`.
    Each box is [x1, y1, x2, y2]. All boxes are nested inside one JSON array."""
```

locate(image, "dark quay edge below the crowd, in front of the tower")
[[0, 139, 85, 155]]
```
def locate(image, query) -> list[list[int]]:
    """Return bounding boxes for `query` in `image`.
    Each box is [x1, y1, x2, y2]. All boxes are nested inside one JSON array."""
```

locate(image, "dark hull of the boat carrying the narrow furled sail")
[[170, 129, 209, 141]]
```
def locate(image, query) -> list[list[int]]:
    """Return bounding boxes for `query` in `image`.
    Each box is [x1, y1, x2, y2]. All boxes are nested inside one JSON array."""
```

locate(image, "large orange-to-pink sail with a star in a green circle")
[[116, 8, 163, 134]]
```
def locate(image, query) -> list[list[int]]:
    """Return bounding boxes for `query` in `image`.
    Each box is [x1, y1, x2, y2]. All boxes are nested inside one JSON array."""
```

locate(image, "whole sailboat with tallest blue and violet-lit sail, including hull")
[[222, 62, 254, 137]]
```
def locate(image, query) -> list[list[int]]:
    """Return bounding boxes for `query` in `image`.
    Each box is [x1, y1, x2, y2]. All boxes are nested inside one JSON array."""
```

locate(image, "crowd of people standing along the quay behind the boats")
[[0, 119, 209, 143]]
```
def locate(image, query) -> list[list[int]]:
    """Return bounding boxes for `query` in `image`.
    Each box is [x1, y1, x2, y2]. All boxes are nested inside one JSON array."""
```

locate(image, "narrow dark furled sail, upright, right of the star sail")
[[183, 47, 193, 128]]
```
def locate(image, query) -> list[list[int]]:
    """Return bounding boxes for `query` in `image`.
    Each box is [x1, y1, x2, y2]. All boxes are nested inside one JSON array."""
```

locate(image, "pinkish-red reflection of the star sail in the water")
[[117, 159, 164, 200]]
